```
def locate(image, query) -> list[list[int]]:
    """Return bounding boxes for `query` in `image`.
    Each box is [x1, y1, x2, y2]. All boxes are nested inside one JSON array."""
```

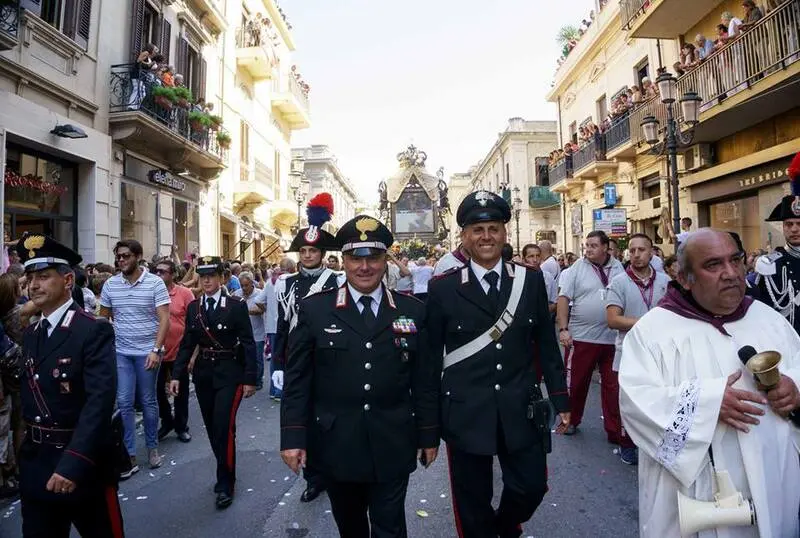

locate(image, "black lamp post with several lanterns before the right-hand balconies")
[[641, 72, 703, 238]]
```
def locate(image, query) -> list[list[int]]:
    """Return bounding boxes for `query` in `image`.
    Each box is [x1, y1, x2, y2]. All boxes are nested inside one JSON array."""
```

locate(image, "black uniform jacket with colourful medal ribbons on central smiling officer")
[[281, 285, 439, 482]]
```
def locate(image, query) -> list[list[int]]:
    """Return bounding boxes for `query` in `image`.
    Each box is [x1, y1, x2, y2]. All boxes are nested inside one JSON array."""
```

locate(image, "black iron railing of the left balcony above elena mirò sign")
[[109, 64, 228, 160]]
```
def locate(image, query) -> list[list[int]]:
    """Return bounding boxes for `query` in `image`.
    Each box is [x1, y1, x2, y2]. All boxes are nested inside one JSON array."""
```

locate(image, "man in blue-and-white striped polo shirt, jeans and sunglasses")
[[100, 239, 170, 479]]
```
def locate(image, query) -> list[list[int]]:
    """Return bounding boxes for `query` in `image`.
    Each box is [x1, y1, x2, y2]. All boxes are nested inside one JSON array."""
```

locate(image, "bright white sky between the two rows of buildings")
[[281, 0, 594, 203]]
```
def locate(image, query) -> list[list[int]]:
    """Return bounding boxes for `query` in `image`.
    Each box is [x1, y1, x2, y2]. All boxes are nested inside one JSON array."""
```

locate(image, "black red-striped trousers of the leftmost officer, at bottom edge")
[[21, 485, 125, 538]]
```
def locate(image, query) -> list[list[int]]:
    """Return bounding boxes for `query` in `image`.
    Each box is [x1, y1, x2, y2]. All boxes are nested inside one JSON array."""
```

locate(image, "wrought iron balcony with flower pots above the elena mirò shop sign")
[[109, 64, 230, 179]]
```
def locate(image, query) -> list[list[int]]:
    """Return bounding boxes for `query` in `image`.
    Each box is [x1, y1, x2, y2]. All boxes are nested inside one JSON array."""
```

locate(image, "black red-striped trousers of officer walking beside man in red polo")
[[194, 377, 243, 495]]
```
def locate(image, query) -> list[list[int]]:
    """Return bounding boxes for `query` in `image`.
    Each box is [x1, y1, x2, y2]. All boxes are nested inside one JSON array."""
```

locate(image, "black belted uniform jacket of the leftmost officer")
[[20, 302, 117, 499]]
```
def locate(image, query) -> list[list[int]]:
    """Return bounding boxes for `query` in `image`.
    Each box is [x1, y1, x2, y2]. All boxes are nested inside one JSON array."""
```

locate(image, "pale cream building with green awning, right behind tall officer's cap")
[[466, 118, 562, 250]]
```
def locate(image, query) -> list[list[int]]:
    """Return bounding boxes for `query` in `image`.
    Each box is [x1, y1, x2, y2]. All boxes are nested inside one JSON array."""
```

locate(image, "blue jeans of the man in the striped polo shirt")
[[117, 353, 158, 456]]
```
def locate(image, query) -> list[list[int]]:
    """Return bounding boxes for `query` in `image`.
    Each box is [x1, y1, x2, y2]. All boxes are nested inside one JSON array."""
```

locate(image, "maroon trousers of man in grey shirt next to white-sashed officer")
[[567, 341, 634, 448]]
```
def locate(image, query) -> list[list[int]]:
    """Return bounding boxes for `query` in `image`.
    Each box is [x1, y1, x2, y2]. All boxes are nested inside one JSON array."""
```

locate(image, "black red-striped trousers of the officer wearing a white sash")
[[447, 421, 547, 538]]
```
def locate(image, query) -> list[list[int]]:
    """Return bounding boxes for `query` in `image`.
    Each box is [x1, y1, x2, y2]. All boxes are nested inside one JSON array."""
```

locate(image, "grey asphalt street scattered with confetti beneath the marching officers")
[[0, 372, 637, 538]]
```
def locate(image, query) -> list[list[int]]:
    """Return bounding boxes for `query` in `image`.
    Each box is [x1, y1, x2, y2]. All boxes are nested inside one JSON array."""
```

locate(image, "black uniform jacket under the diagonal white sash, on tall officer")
[[425, 264, 569, 455]]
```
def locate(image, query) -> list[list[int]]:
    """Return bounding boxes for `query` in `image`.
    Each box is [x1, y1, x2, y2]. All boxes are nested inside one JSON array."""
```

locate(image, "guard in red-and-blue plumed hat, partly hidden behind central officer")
[[272, 192, 338, 502]]
